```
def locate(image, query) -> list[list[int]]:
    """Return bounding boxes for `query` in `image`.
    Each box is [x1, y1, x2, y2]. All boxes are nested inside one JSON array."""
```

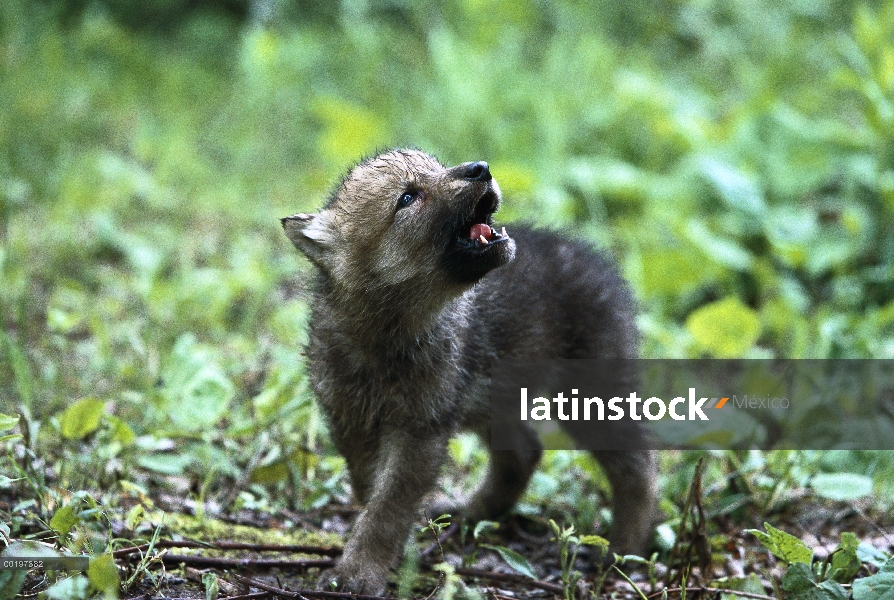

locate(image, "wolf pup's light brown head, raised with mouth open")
[[282, 150, 515, 293]]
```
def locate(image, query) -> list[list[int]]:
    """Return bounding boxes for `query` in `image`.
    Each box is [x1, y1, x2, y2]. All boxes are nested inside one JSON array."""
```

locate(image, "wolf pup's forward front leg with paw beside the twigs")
[[320, 431, 448, 595]]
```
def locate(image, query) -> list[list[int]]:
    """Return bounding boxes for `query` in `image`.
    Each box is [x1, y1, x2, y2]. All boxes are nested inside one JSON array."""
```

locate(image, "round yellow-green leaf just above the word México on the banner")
[[686, 296, 761, 358]]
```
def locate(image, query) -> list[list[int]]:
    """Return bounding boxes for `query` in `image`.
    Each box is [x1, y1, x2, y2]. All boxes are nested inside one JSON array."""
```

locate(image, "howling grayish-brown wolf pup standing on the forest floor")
[[282, 150, 655, 594]]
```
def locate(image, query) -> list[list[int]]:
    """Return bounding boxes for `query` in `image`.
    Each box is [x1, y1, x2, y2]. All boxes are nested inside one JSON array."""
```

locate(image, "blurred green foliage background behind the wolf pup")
[[0, 0, 894, 506]]
